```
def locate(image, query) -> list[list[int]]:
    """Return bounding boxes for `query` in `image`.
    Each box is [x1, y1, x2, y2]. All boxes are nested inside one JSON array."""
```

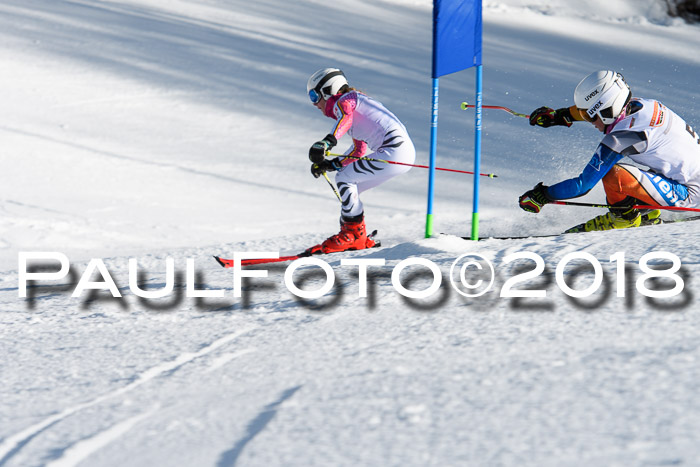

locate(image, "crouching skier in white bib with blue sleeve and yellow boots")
[[519, 70, 700, 232]]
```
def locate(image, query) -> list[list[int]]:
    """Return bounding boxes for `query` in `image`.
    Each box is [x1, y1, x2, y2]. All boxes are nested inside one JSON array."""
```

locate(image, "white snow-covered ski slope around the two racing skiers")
[[0, 0, 700, 466]]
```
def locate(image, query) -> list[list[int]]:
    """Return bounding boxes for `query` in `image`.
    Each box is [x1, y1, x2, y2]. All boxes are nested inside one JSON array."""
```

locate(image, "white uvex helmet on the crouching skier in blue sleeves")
[[574, 70, 632, 125]]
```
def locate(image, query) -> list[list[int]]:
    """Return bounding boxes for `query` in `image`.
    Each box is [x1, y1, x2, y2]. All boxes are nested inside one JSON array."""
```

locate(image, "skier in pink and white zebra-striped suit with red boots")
[[306, 68, 416, 253]]
